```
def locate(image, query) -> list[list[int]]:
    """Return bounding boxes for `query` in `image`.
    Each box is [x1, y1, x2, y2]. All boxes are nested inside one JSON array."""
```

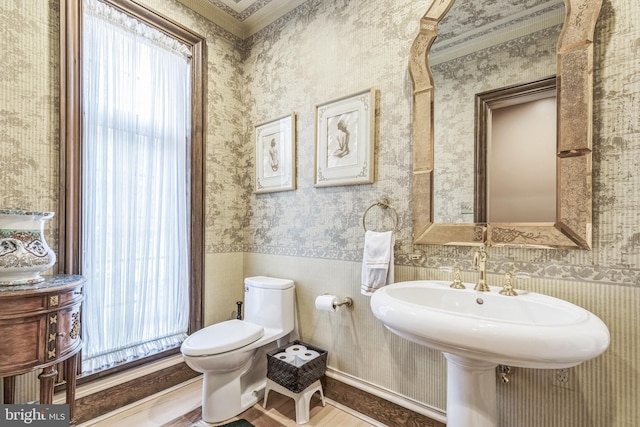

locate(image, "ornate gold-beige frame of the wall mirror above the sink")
[[409, 0, 602, 249]]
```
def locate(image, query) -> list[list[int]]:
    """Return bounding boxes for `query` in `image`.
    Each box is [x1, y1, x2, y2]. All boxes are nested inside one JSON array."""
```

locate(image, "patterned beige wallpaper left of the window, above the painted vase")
[[0, 0, 60, 232]]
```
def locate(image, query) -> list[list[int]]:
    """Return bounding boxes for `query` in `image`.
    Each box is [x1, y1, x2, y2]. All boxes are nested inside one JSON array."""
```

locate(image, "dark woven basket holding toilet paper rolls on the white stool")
[[267, 340, 327, 393]]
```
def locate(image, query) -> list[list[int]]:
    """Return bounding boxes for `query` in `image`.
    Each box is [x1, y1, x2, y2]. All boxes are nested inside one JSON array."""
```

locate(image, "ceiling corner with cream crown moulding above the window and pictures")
[[174, 0, 306, 39]]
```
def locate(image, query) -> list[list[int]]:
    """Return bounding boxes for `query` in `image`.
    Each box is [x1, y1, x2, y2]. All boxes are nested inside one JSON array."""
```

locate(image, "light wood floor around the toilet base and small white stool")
[[79, 378, 384, 427]]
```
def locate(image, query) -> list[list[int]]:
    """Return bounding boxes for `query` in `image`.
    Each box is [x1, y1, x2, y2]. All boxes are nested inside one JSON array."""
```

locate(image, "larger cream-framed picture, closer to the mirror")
[[315, 89, 375, 187]]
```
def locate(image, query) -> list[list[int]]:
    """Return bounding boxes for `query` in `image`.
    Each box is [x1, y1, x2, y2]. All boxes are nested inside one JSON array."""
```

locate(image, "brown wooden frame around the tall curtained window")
[[57, 0, 206, 372]]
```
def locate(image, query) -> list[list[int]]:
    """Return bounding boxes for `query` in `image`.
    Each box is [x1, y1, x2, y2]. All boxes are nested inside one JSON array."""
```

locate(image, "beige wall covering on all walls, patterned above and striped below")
[[0, 0, 640, 427]]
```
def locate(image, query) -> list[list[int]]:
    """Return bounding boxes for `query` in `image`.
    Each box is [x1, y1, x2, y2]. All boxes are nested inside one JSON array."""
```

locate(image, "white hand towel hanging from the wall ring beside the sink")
[[360, 231, 395, 295]]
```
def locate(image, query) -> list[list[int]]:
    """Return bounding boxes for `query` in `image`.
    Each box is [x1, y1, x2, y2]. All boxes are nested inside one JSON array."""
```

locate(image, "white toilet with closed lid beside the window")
[[180, 276, 295, 423]]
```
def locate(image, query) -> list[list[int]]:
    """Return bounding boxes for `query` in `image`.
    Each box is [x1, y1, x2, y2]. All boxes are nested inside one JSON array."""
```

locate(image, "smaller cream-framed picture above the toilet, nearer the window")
[[255, 113, 296, 193]]
